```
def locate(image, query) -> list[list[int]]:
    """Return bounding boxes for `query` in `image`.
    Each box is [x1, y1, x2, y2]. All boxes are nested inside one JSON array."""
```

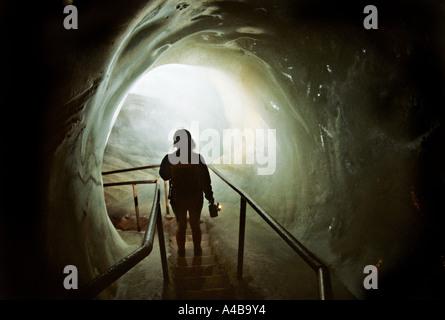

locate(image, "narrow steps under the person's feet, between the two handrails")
[[167, 218, 234, 300]]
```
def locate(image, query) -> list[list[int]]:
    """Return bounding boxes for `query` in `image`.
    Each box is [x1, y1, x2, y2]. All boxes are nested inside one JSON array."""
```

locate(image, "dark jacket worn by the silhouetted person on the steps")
[[159, 151, 214, 203]]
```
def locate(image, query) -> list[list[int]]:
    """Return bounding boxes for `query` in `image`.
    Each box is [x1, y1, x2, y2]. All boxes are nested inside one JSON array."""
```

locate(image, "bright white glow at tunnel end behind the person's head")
[[107, 64, 280, 175]]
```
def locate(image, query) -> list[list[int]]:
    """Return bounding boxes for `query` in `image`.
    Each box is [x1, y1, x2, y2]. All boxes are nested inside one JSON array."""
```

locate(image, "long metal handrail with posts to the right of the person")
[[208, 165, 332, 300]]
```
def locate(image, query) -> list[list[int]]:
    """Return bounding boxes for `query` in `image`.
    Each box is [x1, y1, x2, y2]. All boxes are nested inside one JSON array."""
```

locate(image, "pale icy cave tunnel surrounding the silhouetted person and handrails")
[[0, 0, 445, 299]]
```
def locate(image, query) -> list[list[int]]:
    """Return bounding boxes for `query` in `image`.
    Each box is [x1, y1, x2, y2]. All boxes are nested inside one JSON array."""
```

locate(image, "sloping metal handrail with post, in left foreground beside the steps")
[[75, 180, 169, 299]]
